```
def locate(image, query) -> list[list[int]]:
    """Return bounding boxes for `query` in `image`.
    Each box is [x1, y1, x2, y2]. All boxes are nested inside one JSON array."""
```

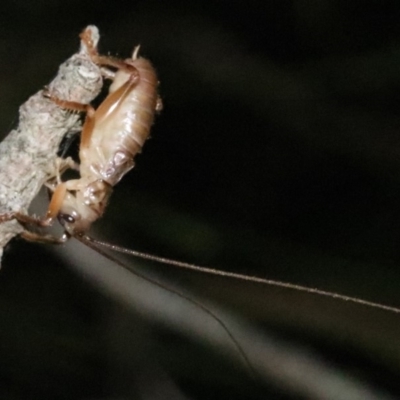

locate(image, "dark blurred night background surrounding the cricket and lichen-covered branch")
[[0, 0, 400, 400]]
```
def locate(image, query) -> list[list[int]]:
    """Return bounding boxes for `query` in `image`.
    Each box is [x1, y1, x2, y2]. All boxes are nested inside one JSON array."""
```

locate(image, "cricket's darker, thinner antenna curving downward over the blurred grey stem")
[[74, 235, 256, 380]]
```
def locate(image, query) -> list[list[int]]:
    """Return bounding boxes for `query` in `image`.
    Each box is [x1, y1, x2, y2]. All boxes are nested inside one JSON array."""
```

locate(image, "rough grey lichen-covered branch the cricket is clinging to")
[[0, 26, 103, 260]]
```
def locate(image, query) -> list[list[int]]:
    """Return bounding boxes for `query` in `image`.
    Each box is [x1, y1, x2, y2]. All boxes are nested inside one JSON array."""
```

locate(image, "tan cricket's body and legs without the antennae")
[[1, 30, 162, 243]]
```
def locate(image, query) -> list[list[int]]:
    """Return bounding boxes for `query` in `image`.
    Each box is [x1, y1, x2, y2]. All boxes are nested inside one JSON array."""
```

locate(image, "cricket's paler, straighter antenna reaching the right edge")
[[82, 235, 400, 316]]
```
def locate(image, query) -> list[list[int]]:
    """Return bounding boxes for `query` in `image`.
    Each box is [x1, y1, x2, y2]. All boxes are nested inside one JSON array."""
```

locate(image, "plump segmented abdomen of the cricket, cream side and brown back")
[[81, 58, 158, 186]]
